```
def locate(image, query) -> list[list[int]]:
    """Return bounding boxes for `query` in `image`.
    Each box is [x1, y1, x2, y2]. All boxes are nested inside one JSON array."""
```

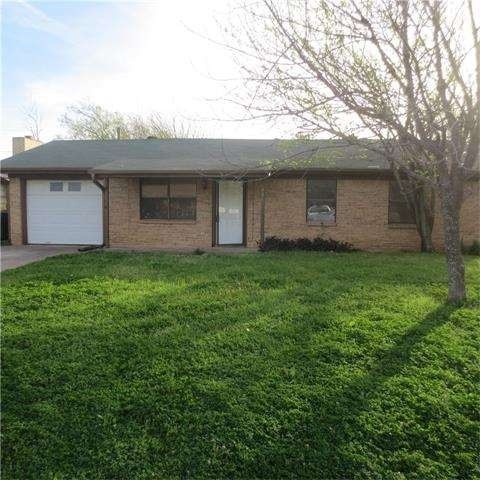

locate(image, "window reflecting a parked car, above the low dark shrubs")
[[307, 178, 337, 224]]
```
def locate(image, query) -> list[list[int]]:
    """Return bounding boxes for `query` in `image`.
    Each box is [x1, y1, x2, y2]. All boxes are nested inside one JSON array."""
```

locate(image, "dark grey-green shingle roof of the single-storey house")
[[0, 139, 388, 174]]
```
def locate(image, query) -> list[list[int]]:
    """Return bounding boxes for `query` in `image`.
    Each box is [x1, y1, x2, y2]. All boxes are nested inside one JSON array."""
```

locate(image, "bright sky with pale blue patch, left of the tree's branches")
[[0, 0, 291, 158]]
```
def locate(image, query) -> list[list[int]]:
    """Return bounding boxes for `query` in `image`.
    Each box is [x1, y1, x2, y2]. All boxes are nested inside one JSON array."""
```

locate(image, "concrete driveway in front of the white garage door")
[[0, 245, 79, 272]]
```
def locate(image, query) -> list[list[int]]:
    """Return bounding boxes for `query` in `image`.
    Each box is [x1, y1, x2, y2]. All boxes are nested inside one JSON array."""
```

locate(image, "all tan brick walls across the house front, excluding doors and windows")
[[9, 177, 480, 251]]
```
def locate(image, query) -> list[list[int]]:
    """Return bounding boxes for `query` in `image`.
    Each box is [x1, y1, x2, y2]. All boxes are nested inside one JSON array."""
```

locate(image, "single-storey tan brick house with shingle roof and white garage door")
[[1, 139, 480, 250]]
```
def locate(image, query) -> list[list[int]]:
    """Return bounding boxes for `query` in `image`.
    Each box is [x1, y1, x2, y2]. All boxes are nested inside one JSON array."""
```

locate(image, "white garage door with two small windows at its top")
[[27, 180, 103, 245]]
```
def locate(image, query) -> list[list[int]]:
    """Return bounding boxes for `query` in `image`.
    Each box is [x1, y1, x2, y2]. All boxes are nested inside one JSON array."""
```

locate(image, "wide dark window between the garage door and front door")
[[140, 179, 197, 220]]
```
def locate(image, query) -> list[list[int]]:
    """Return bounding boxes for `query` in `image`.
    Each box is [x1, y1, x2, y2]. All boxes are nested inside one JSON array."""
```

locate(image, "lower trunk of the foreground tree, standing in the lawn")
[[440, 185, 466, 303]]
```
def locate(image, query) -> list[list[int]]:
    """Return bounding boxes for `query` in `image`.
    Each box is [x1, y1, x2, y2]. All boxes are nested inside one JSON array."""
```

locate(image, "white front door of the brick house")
[[218, 180, 243, 245]]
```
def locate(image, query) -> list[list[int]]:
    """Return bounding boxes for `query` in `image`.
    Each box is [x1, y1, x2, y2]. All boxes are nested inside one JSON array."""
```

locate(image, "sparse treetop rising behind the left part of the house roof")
[[60, 102, 198, 140]]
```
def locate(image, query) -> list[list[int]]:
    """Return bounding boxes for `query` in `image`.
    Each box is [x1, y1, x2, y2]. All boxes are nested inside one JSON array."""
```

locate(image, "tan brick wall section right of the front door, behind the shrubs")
[[248, 178, 420, 250]]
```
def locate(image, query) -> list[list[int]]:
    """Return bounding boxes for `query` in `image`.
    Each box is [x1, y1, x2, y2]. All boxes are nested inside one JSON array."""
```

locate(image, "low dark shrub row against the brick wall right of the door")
[[258, 236, 357, 252]]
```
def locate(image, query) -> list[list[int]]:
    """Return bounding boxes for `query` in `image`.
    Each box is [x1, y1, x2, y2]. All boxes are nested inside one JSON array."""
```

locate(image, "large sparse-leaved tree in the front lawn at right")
[[230, 0, 480, 302]]
